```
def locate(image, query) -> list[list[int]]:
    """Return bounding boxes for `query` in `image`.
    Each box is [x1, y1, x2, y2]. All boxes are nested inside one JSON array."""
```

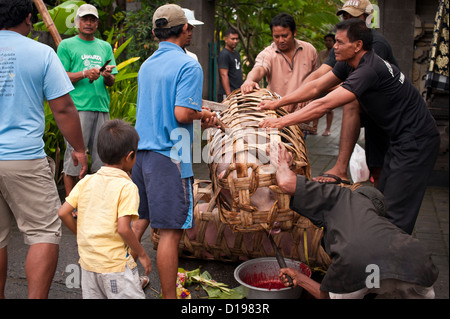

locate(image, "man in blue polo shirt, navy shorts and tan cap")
[[132, 4, 214, 299]]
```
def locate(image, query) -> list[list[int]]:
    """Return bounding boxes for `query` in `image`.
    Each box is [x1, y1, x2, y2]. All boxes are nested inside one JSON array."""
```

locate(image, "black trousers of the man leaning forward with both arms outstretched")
[[378, 130, 440, 234]]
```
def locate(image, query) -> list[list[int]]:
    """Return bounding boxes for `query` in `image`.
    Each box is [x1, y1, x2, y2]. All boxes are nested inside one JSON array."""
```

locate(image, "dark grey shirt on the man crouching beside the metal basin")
[[290, 175, 438, 293]]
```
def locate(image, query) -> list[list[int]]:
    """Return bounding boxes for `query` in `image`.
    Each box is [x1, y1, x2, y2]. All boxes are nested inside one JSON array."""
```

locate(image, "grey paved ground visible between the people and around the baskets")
[[1, 109, 449, 299]]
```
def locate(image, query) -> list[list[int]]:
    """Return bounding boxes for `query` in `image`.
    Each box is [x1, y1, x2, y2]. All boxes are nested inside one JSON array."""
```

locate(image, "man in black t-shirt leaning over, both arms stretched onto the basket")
[[260, 19, 440, 234]]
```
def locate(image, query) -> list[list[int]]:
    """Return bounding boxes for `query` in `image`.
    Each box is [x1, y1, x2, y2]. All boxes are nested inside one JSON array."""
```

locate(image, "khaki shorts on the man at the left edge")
[[0, 158, 61, 248]]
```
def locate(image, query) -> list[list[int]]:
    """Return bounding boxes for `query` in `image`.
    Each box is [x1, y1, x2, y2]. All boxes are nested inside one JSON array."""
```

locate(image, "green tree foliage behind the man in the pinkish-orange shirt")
[[216, 0, 342, 72]]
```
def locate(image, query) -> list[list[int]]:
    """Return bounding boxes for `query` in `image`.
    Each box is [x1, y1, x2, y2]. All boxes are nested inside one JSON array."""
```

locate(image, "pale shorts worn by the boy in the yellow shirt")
[[81, 263, 145, 299]]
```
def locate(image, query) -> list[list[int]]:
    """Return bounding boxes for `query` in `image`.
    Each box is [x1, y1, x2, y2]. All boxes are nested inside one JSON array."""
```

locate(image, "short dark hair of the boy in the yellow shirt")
[[97, 119, 139, 165]]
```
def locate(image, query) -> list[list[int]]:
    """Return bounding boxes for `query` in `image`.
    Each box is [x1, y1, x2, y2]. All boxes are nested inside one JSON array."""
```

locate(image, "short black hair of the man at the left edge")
[[0, 0, 33, 30]]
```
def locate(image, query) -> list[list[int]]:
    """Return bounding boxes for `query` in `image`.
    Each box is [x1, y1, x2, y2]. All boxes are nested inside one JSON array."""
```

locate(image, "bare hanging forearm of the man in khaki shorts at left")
[[48, 94, 88, 178]]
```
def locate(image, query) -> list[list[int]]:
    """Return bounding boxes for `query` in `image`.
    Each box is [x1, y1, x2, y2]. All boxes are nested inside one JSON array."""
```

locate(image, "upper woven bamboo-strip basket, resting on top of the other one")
[[208, 89, 311, 232]]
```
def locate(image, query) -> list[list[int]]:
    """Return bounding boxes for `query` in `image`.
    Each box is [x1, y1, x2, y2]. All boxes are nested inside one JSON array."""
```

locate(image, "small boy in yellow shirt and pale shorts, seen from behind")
[[59, 120, 152, 299]]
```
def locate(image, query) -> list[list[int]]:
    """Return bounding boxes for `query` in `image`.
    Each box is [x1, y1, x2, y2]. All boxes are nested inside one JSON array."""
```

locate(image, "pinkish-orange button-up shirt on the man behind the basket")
[[255, 39, 320, 112]]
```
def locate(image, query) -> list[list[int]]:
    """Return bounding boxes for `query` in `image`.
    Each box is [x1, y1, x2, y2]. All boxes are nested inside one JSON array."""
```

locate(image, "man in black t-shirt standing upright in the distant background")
[[218, 29, 243, 102]]
